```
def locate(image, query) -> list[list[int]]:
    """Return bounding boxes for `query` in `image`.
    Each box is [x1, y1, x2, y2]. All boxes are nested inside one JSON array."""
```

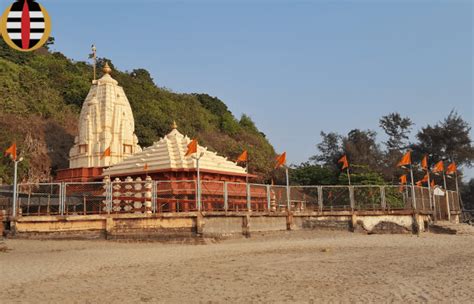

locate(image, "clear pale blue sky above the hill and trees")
[[0, 0, 474, 177]]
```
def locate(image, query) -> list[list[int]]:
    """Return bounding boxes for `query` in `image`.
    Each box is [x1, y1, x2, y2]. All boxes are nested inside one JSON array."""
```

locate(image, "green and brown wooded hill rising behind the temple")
[[0, 40, 275, 182]]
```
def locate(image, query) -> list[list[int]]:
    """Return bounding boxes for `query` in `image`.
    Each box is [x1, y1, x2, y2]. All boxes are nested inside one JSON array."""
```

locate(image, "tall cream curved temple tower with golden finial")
[[69, 64, 141, 168]]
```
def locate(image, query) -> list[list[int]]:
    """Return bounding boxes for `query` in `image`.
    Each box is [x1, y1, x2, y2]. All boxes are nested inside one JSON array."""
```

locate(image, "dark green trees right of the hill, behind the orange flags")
[[291, 111, 474, 189]]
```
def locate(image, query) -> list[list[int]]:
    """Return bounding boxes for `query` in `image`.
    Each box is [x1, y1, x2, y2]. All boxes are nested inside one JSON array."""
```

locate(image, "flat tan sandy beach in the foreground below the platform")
[[0, 231, 474, 303]]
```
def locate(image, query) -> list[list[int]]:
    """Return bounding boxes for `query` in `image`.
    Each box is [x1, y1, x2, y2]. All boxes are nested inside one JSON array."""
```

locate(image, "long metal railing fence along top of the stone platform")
[[0, 178, 461, 218]]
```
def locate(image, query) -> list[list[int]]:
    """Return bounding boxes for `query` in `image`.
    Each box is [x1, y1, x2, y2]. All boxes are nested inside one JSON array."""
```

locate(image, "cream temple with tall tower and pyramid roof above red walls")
[[57, 64, 250, 182]]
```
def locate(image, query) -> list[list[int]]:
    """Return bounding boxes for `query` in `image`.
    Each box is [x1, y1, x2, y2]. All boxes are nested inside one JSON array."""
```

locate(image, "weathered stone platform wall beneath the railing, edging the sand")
[[4, 210, 436, 242]]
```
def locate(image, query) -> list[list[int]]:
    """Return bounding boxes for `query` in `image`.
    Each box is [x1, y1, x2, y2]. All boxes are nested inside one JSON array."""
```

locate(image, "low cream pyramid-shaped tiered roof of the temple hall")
[[102, 124, 247, 176]]
